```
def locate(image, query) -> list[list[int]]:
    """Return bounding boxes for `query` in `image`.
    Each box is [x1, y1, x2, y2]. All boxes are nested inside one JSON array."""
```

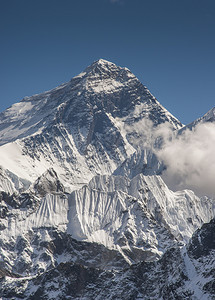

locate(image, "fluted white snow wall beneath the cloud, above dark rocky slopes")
[[70, 174, 215, 248]]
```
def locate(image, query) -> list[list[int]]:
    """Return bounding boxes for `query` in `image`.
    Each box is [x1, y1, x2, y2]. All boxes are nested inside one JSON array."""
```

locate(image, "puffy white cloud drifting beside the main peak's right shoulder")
[[157, 123, 215, 196]]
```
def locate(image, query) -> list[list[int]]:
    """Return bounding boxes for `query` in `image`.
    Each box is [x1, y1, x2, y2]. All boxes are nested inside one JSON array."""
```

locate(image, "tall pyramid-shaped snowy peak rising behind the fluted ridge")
[[0, 59, 182, 190]]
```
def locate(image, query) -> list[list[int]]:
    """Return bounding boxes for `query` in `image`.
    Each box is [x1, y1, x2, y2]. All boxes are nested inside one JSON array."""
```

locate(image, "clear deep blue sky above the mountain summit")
[[0, 0, 215, 124]]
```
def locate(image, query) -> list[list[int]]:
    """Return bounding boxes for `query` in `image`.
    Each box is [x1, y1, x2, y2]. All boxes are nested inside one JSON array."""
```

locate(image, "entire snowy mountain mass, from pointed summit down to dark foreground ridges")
[[0, 59, 215, 299]]
